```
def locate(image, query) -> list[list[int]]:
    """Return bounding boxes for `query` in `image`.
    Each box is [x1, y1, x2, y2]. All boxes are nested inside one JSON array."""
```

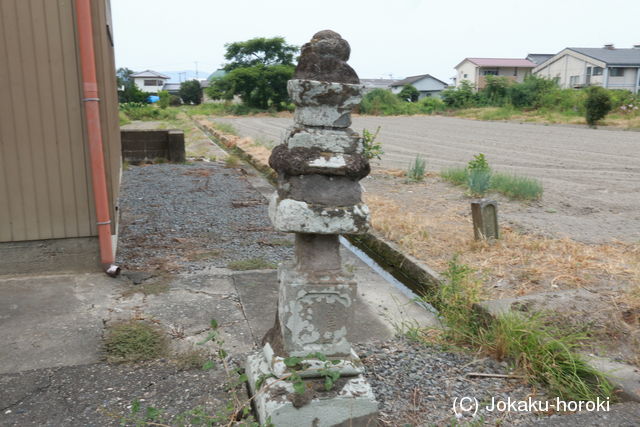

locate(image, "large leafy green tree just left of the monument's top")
[[207, 37, 298, 109]]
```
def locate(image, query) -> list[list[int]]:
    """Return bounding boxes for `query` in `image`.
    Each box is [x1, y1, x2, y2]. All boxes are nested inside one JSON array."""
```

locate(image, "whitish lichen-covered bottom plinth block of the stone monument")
[[246, 351, 378, 427]]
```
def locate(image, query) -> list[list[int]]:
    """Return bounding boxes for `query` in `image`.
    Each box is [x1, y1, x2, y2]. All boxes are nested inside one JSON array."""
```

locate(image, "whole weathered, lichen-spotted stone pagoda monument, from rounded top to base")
[[247, 30, 377, 426]]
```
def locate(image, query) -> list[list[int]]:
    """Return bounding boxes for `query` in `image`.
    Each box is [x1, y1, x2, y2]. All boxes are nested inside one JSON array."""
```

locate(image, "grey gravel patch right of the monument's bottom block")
[[358, 337, 544, 426]]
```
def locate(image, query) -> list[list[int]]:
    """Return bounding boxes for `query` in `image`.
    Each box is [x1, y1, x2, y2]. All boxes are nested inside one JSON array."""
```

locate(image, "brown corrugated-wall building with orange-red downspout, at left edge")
[[0, 0, 122, 275]]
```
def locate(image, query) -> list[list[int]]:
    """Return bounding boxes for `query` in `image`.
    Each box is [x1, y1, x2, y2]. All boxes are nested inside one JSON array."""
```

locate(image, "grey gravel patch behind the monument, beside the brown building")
[[118, 162, 293, 272]]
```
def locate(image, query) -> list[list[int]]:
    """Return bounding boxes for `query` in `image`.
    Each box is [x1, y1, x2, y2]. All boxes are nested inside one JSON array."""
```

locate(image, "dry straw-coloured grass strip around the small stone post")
[[366, 193, 640, 299]]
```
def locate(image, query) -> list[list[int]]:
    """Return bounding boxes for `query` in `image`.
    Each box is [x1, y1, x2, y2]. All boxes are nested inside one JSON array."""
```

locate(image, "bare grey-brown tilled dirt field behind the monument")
[[213, 116, 640, 243]]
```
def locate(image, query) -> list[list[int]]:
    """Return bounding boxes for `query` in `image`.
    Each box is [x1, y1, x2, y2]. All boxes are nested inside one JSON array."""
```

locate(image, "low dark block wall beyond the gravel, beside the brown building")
[[120, 129, 185, 163]]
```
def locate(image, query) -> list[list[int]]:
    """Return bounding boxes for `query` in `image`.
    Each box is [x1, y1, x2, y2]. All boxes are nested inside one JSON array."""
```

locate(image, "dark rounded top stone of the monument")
[[293, 30, 360, 84]]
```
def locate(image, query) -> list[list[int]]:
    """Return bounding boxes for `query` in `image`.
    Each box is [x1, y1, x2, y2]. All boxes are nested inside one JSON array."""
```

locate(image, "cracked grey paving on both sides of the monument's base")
[[0, 239, 436, 426]]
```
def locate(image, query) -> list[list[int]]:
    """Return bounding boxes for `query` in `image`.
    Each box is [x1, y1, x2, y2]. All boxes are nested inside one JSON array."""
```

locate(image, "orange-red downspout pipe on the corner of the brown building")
[[76, 0, 120, 277]]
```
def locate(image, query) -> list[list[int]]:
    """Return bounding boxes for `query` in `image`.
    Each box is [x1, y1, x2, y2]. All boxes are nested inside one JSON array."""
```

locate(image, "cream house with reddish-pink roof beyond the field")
[[454, 58, 536, 90]]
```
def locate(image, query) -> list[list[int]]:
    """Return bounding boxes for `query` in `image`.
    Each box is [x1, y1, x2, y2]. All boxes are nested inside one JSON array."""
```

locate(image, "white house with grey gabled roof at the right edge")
[[533, 44, 640, 93]]
